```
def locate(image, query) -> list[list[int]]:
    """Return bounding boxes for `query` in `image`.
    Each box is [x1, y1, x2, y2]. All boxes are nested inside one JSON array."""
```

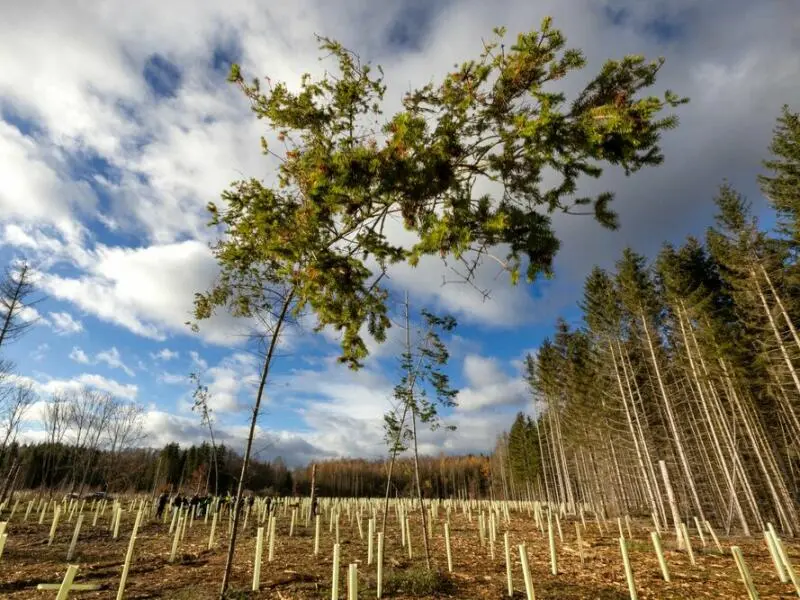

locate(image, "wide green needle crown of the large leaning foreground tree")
[[195, 18, 686, 368]]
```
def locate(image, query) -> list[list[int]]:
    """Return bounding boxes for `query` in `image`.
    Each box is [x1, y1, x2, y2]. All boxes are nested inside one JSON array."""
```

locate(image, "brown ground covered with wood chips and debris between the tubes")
[[0, 502, 800, 600]]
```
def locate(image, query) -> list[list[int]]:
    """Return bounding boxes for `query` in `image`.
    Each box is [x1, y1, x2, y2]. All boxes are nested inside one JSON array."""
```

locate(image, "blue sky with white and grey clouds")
[[0, 0, 800, 464]]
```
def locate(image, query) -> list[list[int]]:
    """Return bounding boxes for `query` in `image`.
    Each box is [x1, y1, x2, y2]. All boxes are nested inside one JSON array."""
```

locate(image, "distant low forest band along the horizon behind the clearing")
[[0, 443, 502, 502]]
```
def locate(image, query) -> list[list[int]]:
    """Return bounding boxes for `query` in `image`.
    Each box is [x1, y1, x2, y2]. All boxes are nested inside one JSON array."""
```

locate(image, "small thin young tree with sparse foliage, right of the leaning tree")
[[382, 294, 458, 570]]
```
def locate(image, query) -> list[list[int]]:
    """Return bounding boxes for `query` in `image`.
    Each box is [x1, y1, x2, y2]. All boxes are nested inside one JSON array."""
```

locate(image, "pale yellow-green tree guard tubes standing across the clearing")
[[0, 494, 800, 600]]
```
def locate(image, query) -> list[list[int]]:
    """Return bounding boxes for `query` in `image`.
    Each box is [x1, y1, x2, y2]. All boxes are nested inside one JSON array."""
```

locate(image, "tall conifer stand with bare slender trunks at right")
[[495, 107, 800, 534]]
